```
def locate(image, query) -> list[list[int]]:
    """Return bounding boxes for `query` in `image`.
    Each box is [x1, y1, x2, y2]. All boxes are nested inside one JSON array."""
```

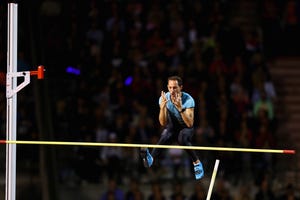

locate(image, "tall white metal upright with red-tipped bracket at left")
[[5, 3, 44, 200]]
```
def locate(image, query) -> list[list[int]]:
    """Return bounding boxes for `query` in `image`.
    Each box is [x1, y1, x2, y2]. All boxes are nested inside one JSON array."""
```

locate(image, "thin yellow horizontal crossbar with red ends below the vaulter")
[[0, 140, 296, 154]]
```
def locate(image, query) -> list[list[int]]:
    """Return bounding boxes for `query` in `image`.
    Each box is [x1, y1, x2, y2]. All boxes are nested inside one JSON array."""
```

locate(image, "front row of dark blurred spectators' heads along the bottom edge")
[[99, 177, 299, 200]]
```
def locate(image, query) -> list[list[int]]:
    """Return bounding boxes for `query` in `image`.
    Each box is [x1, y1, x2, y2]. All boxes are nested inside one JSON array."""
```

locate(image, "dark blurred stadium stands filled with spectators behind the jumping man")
[[0, 0, 300, 200]]
